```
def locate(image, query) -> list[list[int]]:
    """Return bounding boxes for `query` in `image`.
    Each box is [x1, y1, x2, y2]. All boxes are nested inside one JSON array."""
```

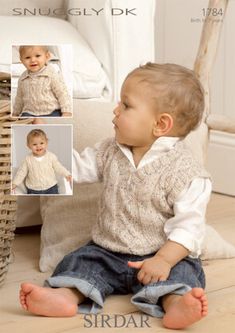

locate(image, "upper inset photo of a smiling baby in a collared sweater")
[[11, 44, 73, 118]]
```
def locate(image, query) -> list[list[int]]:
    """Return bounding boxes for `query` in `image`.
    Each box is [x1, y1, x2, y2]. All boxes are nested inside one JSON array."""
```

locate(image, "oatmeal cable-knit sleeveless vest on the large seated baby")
[[92, 139, 209, 255]]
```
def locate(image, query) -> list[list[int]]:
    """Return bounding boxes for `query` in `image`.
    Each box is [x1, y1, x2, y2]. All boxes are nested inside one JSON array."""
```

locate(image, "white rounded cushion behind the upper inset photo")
[[0, 16, 109, 98]]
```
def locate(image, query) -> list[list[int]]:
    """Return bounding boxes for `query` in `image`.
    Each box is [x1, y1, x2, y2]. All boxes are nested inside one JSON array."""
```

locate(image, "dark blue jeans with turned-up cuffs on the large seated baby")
[[45, 242, 205, 317]]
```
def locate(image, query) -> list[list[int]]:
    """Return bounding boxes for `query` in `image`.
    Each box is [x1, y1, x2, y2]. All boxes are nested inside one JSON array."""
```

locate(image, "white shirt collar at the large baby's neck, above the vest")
[[117, 136, 180, 169]]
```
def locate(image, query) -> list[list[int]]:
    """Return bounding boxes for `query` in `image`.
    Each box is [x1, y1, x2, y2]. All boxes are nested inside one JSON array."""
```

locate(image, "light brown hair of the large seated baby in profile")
[[127, 62, 204, 137]]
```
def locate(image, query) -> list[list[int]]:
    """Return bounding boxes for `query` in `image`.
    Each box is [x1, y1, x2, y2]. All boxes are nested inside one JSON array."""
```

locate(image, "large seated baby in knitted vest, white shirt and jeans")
[[20, 63, 211, 329]]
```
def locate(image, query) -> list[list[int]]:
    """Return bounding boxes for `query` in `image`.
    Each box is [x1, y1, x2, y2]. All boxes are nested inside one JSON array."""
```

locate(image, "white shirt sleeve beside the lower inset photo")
[[72, 143, 100, 183]]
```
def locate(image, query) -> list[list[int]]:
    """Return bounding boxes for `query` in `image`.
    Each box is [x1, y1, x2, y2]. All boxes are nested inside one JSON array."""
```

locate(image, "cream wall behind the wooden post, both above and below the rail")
[[156, 0, 235, 195]]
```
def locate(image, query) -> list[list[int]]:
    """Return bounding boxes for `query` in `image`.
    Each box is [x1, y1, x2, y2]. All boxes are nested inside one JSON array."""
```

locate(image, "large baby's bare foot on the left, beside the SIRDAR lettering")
[[20, 283, 79, 317]]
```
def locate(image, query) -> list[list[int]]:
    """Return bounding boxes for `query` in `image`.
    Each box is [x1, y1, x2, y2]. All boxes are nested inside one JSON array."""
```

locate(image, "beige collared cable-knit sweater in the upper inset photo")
[[13, 65, 72, 116]]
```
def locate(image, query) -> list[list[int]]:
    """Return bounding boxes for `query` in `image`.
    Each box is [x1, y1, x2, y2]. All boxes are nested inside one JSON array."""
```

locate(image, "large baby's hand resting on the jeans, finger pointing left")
[[128, 255, 172, 285]]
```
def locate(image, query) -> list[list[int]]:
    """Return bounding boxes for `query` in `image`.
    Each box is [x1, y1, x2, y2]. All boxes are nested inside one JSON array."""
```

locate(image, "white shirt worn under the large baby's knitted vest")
[[73, 137, 212, 257]]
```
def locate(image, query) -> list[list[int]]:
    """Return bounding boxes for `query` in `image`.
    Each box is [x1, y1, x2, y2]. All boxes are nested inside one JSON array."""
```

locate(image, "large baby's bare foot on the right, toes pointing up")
[[163, 288, 207, 329]]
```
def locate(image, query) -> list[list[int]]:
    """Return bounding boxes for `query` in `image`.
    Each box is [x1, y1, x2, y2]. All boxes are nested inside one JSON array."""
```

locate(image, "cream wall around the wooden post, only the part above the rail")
[[156, 0, 235, 116]]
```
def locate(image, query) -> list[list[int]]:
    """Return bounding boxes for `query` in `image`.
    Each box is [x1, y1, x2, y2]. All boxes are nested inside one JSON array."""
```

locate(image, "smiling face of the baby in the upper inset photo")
[[20, 46, 50, 73]]
